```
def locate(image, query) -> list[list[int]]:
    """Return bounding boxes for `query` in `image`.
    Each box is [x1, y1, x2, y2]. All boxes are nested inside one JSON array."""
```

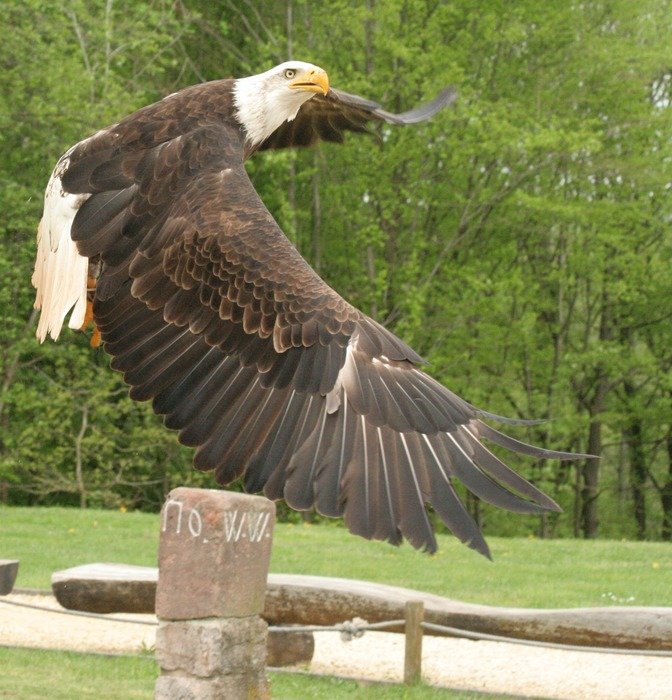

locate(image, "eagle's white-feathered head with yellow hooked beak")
[[233, 61, 329, 146]]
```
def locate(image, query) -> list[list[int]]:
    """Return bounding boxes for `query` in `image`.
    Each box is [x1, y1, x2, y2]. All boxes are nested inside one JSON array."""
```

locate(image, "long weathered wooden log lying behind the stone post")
[[52, 564, 672, 651]]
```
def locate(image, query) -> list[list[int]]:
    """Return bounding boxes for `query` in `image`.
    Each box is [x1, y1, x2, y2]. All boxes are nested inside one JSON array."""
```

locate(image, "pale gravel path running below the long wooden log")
[[0, 594, 672, 700]]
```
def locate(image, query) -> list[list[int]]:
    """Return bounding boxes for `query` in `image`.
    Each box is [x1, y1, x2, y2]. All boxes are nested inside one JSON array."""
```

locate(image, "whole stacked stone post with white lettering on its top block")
[[155, 488, 275, 700]]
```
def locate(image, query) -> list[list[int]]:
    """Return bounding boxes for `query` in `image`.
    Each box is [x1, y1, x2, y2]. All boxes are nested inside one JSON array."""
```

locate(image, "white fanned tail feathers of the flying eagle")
[[32, 153, 90, 342]]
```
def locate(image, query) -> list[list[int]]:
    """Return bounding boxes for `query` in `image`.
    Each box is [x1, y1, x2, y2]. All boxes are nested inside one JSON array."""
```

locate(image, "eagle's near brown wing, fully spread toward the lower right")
[[63, 119, 573, 555]]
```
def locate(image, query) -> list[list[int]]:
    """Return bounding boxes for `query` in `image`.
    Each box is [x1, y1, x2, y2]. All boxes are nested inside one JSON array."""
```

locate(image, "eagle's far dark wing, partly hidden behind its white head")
[[259, 87, 457, 150]]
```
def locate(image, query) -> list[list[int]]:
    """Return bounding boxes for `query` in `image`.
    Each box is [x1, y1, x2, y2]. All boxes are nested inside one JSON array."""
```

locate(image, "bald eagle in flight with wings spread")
[[33, 61, 576, 556]]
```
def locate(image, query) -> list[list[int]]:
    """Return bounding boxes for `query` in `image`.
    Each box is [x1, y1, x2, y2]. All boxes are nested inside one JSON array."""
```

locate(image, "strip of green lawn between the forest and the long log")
[[0, 507, 672, 608]]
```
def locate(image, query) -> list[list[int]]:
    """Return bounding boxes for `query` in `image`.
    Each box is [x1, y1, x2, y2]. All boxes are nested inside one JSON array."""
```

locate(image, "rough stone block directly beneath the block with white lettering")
[[156, 615, 266, 678]]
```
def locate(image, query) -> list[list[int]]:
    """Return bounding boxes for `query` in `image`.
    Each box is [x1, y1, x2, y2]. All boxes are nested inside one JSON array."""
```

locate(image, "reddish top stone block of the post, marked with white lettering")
[[156, 488, 275, 620]]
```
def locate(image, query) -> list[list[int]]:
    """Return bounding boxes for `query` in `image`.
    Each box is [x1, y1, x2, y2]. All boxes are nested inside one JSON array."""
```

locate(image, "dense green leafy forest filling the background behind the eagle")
[[0, 0, 672, 540]]
